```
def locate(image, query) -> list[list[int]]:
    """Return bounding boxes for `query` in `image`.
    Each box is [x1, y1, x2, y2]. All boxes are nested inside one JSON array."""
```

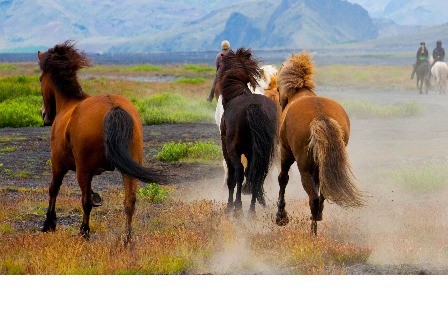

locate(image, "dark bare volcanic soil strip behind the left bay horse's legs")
[[0, 123, 222, 191]]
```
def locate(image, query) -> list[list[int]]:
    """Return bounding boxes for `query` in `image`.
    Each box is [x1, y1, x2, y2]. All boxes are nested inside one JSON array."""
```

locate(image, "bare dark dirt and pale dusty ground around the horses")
[[0, 87, 448, 275]]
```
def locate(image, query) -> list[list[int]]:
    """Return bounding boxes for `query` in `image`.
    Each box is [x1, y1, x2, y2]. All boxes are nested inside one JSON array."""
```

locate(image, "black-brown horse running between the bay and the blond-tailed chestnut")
[[219, 48, 277, 213]]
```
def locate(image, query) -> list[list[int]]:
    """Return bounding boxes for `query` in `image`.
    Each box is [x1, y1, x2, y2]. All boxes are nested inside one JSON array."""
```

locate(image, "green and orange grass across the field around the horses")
[[0, 63, 424, 276]]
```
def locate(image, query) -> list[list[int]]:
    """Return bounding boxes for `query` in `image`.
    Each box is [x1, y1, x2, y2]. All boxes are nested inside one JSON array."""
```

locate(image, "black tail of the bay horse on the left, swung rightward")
[[103, 106, 166, 184]]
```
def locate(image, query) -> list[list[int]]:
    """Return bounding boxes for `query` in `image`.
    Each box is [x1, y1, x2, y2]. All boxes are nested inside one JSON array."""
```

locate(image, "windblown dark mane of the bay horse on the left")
[[39, 40, 91, 99]]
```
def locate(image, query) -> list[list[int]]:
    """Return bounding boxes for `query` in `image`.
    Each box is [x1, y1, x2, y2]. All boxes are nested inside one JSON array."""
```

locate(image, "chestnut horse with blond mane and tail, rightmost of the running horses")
[[277, 51, 364, 235]]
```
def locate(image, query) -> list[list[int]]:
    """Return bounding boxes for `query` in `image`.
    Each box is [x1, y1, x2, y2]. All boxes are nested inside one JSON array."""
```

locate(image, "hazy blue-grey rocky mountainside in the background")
[[0, 0, 378, 52]]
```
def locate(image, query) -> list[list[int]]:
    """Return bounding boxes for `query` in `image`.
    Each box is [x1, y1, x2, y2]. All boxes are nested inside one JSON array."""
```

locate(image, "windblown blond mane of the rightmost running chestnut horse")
[[277, 51, 316, 96]]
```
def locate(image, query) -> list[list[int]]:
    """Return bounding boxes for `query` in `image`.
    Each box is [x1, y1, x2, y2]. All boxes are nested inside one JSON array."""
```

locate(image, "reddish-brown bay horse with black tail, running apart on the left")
[[38, 40, 164, 240]]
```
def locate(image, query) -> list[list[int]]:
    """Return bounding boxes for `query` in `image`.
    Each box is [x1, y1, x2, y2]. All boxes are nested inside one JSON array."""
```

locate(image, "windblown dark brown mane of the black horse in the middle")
[[218, 47, 262, 103]]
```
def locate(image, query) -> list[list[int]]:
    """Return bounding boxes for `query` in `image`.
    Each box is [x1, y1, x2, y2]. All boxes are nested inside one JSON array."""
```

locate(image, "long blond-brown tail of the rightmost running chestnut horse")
[[308, 116, 365, 208]]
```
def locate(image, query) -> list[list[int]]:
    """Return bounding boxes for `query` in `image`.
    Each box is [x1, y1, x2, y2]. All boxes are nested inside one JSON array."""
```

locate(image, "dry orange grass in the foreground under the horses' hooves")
[[0, 186, 369, 276]]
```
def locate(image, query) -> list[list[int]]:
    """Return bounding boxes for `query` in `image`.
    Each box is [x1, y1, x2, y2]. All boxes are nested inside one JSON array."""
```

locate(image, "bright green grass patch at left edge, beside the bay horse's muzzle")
[[0, 96, 43, 128]]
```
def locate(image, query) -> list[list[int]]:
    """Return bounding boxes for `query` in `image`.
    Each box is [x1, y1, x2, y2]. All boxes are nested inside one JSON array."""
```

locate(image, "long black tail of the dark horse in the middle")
[[243, 104, 277, 206]]
